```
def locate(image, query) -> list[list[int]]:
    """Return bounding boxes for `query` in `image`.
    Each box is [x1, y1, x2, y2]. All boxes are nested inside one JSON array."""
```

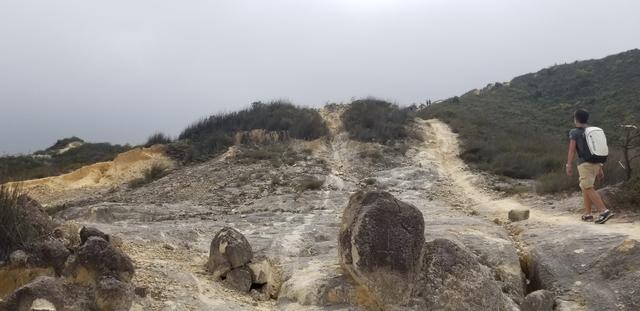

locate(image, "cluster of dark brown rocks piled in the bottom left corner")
[[0, 224, 134, 311]]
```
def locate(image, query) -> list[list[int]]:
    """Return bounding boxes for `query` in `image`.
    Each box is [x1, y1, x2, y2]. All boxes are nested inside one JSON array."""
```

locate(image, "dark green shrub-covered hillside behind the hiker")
[[419, 49, 640, 188]]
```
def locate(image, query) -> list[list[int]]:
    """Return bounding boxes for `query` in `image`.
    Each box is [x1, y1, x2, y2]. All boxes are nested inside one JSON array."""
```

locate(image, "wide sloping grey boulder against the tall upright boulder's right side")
[[413, 239, 515, 311]]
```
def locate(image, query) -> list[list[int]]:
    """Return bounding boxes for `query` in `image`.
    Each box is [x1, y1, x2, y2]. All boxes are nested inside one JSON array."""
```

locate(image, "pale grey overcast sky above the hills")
[[0, 0, 640, 154]]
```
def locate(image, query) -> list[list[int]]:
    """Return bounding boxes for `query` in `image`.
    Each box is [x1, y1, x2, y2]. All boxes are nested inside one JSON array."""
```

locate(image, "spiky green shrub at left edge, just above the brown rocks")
[[0, 186, 52, 260]]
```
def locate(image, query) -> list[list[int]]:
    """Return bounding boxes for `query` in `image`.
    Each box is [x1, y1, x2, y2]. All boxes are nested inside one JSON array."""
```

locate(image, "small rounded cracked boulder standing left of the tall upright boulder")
[[207, 227, 253, 278]]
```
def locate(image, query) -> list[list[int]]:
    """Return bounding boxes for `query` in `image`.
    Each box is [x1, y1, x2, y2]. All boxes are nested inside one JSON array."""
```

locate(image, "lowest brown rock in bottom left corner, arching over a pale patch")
[[0, 277, 65, 311]]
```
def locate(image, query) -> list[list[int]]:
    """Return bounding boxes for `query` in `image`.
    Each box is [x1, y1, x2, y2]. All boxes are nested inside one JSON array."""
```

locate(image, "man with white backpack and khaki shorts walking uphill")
[[565, 109, 613, 224]]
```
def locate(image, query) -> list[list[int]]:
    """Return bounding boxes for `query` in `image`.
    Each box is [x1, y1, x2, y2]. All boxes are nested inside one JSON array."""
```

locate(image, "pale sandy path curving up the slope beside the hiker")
[[417, 119, 640, 239]]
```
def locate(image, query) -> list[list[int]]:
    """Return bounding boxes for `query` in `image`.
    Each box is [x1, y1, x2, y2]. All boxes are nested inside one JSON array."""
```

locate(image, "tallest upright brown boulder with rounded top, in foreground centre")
[[338, 191, 424, 308]]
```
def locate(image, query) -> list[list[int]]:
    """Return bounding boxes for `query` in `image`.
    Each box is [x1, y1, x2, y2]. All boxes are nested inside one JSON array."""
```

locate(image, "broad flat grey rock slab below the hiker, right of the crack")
[[522, 224, 640, 310]]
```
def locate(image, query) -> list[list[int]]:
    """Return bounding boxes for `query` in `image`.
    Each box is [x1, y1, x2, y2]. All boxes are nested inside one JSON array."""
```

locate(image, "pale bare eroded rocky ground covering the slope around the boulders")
[[7, 108, 640, 310]]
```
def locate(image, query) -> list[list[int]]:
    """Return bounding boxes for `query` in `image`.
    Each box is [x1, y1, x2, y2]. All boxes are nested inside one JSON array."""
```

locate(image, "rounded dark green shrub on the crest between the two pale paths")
[[342, 99, 411, 144]]
